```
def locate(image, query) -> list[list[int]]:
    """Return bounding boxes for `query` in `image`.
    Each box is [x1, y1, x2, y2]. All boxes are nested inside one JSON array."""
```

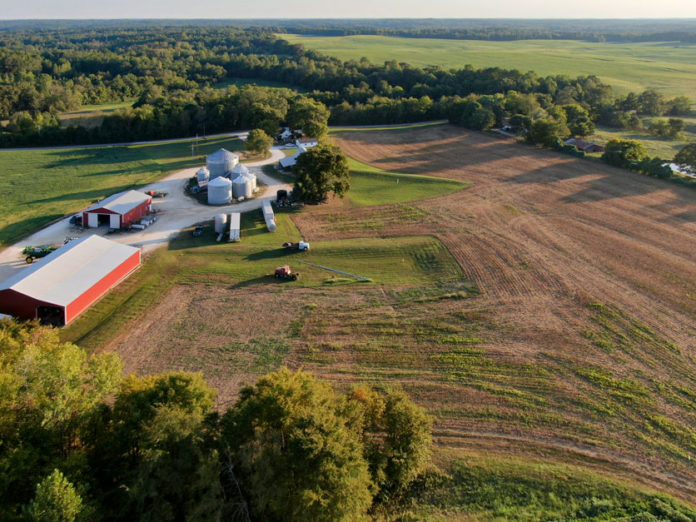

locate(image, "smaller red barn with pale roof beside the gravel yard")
[[82, 190, 152, 228]]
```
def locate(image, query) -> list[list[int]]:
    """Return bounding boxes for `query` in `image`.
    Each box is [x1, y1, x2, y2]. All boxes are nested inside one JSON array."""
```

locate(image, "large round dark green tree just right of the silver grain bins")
[[293, 144, 350, 203]]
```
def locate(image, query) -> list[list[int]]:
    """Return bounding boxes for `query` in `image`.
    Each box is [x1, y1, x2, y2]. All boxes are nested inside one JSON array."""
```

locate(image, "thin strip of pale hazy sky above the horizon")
[[0, 0, 696, 20]]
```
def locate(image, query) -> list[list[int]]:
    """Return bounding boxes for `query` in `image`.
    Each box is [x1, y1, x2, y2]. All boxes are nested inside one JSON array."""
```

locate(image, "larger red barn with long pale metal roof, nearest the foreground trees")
[[0, 235, 140, 326]]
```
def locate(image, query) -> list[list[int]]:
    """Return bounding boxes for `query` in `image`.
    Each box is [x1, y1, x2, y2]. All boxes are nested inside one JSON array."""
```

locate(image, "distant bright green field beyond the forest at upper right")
[[278, 34, 696, 99]]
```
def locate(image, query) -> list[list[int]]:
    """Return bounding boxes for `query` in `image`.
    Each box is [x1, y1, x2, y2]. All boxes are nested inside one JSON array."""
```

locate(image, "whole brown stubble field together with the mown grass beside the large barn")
[[63, 125, 696, 504]]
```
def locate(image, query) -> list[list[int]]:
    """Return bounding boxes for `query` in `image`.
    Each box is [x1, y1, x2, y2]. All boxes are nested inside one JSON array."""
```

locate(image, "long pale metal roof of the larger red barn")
[[0, 235, 138, 306]]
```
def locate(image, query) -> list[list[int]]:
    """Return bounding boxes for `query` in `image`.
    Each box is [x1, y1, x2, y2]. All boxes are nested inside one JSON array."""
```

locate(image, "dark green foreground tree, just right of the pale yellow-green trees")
[[90, 372, 222, 521]]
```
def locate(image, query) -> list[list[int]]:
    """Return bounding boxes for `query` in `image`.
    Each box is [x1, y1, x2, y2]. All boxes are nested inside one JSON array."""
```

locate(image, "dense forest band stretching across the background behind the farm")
[[0, 24, 691, 175]]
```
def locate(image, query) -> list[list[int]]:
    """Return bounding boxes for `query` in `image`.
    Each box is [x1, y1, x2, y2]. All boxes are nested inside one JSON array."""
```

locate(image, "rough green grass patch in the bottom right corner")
[[402, 451, 696, 521]]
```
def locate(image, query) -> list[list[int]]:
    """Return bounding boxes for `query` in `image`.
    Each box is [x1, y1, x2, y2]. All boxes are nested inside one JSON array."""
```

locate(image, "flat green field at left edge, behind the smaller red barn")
[[0, 138, 243, 246]]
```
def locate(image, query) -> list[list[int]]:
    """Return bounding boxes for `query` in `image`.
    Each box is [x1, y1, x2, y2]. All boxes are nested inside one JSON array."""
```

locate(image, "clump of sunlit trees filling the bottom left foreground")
[[0, 320, 431, 521]]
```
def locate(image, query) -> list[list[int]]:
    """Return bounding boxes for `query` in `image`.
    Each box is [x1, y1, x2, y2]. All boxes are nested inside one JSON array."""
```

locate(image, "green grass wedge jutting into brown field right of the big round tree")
[[347, 158, 468, 207]]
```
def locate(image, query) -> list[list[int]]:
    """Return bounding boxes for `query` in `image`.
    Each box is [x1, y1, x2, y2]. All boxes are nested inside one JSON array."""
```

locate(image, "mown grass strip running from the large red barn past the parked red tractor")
[[62, 211, 464, 348]]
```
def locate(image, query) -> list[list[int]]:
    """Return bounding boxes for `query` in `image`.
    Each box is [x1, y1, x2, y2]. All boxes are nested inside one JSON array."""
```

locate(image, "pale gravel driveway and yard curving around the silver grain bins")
[[0, 147, 292, 281]]
